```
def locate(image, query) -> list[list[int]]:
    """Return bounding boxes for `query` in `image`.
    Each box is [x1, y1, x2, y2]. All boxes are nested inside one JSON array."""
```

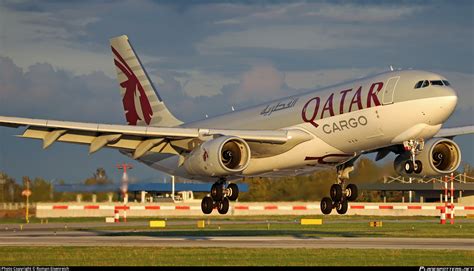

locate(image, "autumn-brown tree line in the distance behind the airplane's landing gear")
[[0, 160, 474, 202]]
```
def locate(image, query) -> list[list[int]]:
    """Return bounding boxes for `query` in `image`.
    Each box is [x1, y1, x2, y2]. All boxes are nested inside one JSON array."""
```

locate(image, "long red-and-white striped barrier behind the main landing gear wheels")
[[36, 202, 474, 218]]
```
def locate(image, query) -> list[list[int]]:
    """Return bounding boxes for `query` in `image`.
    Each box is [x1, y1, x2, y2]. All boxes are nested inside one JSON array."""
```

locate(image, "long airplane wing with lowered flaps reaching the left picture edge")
[[0, 116, 310, 159]]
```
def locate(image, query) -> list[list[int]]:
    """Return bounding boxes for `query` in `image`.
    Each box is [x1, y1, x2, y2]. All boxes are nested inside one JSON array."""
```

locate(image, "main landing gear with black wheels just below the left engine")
[[201, 178, 239, 215]]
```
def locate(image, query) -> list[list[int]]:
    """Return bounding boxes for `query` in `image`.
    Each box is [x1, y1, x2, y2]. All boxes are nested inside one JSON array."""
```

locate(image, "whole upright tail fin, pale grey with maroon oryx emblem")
[[110, 35, 183, 127]]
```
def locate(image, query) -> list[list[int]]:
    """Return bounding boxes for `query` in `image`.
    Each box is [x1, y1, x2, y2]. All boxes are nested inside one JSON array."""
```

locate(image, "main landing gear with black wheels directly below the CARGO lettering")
[[321, 166, 359, 215]]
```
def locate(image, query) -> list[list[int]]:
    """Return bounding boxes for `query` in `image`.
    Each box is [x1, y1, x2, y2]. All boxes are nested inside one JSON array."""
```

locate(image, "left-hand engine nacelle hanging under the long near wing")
[[184, 136, 250, 176]]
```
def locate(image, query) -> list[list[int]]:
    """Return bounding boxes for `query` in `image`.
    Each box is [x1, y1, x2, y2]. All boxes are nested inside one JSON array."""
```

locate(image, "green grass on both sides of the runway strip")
[[0, 216, 474, 266]]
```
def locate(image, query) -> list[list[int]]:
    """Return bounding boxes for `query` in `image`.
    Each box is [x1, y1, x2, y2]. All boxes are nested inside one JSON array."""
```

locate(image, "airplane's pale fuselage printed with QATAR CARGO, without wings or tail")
[[136, 71, 457, 179]]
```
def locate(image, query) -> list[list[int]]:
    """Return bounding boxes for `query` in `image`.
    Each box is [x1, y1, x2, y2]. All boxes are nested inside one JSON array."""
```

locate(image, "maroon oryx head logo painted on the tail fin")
[[112, 46, 153, 125]]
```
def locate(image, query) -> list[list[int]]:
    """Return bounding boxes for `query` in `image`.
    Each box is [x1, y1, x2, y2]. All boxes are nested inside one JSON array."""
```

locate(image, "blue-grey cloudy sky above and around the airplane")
[[0, 0, 474, 185]]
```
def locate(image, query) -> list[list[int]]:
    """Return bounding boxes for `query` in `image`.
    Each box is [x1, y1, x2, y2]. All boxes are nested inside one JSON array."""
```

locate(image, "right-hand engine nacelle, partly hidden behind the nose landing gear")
[[394, 138, 461, 176]]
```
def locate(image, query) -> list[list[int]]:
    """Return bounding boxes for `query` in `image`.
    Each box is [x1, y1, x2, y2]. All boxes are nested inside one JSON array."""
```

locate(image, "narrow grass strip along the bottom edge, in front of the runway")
[[0, 247, 474, 266]]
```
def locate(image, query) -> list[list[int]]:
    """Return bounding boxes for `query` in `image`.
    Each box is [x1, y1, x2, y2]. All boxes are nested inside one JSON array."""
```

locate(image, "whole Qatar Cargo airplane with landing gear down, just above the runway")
[[0, 35, 474, 214]]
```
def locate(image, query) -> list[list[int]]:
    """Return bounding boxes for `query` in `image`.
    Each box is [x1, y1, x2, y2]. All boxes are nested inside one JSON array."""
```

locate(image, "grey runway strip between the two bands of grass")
[[0, 230, 474, 250]]
